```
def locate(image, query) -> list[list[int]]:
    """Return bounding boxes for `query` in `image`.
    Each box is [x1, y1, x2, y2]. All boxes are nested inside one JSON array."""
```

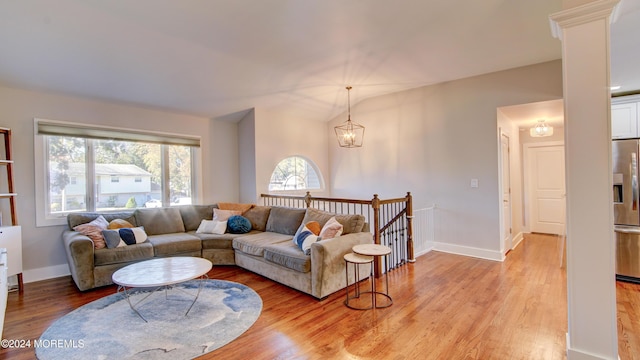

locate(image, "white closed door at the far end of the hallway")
[[528, 145, 565, 235]]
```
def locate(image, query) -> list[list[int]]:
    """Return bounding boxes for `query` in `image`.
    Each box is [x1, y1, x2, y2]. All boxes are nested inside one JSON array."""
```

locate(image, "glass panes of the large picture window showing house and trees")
[[38, 119, 199, 224]]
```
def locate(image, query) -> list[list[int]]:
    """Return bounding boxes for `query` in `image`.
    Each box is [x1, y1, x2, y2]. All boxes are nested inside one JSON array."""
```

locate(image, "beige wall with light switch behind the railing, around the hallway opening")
[[328, 60, 562, 259]]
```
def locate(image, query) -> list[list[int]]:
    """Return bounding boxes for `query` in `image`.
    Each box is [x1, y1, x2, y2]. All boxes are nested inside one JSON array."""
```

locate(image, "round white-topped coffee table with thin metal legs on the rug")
[[111, 256, 212, 322]]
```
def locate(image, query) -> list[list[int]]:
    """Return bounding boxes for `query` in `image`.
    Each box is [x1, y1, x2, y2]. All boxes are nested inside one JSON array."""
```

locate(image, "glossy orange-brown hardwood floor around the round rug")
[[0, 235, 640, 360]]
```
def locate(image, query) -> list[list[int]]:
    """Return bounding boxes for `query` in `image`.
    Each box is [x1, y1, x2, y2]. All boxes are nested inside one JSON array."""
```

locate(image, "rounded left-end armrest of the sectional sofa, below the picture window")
[[62, 230, 95, 291]]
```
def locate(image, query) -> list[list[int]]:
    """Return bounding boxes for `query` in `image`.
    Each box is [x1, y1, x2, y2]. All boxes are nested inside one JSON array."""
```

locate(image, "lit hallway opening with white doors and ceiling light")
[[497, 99, 565, 249]]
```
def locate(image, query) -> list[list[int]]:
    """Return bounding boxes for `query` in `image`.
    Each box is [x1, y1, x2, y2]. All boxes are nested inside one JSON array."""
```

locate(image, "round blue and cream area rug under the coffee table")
[[35, 280, 262, 360]]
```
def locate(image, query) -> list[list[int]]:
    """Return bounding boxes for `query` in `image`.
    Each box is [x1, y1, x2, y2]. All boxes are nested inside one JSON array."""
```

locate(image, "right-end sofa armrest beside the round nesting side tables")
[[311, 232, 373, 298]]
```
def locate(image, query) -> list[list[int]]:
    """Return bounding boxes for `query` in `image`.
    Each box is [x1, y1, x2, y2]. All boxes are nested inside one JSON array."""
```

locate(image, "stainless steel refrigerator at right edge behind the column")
[[612, 139, 640, 283]]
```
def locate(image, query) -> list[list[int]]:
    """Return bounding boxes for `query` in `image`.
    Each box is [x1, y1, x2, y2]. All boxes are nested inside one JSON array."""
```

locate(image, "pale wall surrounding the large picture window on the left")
[[0, 86, 237, 281]]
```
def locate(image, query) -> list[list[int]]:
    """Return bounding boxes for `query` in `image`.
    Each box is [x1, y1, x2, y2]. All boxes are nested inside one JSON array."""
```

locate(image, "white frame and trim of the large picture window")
[[33, 118, 202, 227]]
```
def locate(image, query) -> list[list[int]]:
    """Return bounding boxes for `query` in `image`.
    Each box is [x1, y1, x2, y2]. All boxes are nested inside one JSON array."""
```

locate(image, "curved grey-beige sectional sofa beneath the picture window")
[[62, 205, 372, 299]]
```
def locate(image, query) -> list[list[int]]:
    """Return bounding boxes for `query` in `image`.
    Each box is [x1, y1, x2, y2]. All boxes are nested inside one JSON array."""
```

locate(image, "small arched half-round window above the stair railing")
[[269, 156, 322, 191]]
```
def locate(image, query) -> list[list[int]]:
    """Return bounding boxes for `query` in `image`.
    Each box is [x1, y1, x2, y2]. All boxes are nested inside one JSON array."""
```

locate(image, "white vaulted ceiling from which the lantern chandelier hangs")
[[0, 0, 640, 121]]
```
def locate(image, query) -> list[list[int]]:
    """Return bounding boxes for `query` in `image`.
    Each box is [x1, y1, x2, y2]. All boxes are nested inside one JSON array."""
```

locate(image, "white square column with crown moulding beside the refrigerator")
[[550, 0, 619, 360]]
